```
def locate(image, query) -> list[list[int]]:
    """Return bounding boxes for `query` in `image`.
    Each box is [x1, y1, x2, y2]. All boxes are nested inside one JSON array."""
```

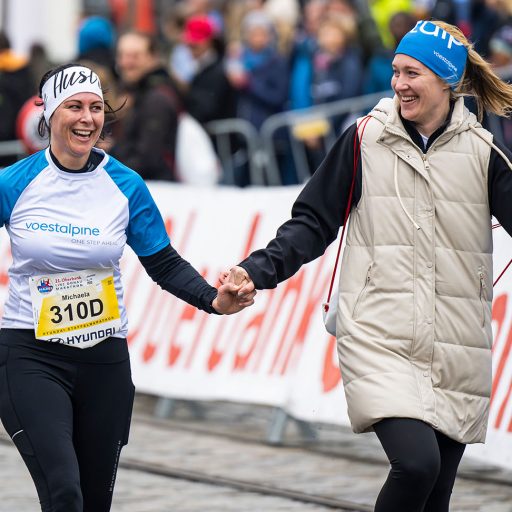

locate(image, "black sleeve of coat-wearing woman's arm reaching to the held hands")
[[240, 124, 362, 289]]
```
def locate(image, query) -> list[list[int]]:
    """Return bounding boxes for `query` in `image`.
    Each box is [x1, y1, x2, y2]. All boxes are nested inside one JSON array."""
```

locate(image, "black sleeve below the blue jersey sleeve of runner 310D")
[[139, 244, 217, 313]]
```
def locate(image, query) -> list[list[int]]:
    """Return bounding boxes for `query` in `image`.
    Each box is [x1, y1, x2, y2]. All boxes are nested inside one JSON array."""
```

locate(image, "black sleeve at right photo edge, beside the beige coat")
[[488, 139, 512, 236]]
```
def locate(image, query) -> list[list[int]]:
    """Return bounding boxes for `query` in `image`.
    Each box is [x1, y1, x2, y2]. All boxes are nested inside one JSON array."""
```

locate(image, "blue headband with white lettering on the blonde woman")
[[395, 21, 468, 89]]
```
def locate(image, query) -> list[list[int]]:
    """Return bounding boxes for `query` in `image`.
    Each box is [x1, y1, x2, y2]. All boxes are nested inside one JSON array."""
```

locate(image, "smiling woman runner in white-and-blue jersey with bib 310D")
[[0, 64, 254, 512]]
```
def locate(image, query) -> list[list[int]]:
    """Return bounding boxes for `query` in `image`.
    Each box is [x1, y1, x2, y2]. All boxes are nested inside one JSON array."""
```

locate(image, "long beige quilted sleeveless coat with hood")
[[337, 98, 492, 443]]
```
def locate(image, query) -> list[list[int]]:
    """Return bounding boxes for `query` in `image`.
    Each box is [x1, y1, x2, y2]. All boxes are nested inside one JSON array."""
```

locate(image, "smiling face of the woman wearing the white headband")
[[50, 92, 105, 169]]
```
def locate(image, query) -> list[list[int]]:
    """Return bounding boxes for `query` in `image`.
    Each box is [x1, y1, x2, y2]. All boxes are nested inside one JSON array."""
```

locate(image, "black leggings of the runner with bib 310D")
[[0, 329, 134, 512]]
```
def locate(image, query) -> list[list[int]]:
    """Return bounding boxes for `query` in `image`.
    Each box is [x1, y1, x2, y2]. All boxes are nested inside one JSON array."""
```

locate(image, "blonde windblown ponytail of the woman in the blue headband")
[[432, 21, 512, 121]]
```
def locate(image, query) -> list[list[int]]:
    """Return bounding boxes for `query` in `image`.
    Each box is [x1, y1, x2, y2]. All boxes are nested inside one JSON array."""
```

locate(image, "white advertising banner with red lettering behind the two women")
[[0, 184, 512, 467]]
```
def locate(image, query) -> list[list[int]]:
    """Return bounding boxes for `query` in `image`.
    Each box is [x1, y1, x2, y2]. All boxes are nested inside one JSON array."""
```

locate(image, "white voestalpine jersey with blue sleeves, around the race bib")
[[0, 149, 169, 337]]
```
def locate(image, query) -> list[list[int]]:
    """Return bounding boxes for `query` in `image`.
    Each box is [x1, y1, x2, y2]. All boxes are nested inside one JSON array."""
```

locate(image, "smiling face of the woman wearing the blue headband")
[[391, 53, 450, 137]]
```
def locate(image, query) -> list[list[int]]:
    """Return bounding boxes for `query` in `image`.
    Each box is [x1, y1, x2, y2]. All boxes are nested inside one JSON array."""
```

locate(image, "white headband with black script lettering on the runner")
[[42, 66, 103, 124]]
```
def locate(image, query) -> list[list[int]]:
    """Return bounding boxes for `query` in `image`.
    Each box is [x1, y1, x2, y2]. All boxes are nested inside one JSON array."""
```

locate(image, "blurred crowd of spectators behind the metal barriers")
[[0, 0, 512, 186]]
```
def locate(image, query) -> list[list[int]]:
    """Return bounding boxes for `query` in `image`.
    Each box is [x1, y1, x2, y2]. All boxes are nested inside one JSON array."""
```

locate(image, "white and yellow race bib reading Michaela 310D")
[[29, 269, 121, 348]]
